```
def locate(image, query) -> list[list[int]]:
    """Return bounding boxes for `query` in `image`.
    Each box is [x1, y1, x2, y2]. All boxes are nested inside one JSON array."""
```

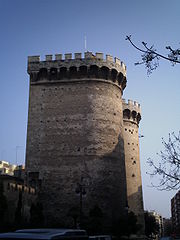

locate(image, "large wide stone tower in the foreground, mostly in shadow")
[[26, 52, 127, 228]]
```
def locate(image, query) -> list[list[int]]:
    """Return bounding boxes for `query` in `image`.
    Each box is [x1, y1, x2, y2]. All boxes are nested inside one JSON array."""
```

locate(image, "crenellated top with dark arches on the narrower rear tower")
[[122, 99, 141, 125]]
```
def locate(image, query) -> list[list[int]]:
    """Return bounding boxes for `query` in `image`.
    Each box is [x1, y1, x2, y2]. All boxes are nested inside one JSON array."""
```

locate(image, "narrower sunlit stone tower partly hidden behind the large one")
[[123, 99, 144, 233]]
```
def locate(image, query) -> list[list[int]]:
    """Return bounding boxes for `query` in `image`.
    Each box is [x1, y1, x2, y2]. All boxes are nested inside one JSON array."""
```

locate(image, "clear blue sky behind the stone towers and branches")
[[0, 0, 180, 217]]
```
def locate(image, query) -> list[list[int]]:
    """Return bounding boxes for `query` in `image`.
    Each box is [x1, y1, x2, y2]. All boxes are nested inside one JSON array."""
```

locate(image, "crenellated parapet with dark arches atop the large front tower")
[[28, 52, 126, 89]]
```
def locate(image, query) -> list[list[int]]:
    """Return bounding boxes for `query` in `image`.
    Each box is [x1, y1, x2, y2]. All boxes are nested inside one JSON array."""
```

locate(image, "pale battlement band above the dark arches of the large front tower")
[[28, 52, 126, 76]]
